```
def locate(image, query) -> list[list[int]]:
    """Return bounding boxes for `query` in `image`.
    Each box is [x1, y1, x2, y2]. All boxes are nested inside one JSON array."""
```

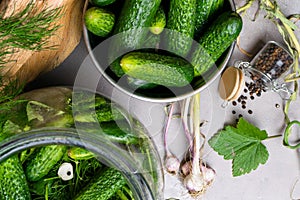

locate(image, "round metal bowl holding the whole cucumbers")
[[83, 0, 235, 103]]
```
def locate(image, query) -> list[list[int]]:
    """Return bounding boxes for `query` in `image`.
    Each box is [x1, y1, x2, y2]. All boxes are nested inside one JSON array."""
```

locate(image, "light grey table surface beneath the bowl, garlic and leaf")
[[30, 0, 300, 200]]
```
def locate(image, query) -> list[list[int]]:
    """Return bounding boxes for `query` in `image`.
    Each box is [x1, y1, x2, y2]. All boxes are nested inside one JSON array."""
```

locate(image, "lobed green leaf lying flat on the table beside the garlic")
[[208, 118, 269, 176]]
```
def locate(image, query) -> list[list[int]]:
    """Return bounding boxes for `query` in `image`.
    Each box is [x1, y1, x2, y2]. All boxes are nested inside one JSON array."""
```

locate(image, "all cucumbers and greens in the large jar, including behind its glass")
[[0, 87, 154, 200]]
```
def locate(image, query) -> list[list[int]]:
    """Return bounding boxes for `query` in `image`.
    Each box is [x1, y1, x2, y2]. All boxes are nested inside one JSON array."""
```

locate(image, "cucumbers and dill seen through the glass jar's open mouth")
[[0, 145, 134, 200]]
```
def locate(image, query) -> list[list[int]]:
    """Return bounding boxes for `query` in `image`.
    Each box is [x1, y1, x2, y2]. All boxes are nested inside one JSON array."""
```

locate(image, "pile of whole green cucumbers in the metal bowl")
[[85, 0, 242, 89]]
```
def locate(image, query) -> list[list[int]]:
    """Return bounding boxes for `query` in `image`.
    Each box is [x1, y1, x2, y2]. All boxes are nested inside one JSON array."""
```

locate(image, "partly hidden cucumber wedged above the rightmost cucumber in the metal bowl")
[[195, 0, 224, 36]]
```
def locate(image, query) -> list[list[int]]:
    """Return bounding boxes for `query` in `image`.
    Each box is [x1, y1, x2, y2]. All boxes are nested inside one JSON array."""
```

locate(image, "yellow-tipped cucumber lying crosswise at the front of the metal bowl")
[[121, 52, 194, 87]]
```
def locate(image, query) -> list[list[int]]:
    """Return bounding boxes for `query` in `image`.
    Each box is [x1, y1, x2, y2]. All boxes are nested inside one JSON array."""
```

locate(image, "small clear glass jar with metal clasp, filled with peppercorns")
[[237, 41, 294, 99]]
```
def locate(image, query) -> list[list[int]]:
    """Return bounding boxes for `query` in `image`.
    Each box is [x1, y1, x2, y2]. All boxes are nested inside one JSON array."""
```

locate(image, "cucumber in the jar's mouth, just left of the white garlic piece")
[[25, 145, 67, 181]]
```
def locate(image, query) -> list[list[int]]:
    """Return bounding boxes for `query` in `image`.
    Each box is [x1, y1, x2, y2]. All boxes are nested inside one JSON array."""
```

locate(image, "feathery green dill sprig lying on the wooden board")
[[0, 1, 62, 53]]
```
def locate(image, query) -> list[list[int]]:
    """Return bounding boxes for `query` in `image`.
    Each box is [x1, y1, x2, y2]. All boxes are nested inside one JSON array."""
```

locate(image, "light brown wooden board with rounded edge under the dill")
[[0, 0, 84, 86]]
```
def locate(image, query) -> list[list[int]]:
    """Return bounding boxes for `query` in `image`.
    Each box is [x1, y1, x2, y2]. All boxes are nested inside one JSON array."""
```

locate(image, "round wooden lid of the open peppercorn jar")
[[219, 66, 244, 101]]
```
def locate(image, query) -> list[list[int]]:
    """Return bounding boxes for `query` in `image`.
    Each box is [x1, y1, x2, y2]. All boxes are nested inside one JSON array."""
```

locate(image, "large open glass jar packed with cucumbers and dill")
[[0, 87, 163, 200]]
